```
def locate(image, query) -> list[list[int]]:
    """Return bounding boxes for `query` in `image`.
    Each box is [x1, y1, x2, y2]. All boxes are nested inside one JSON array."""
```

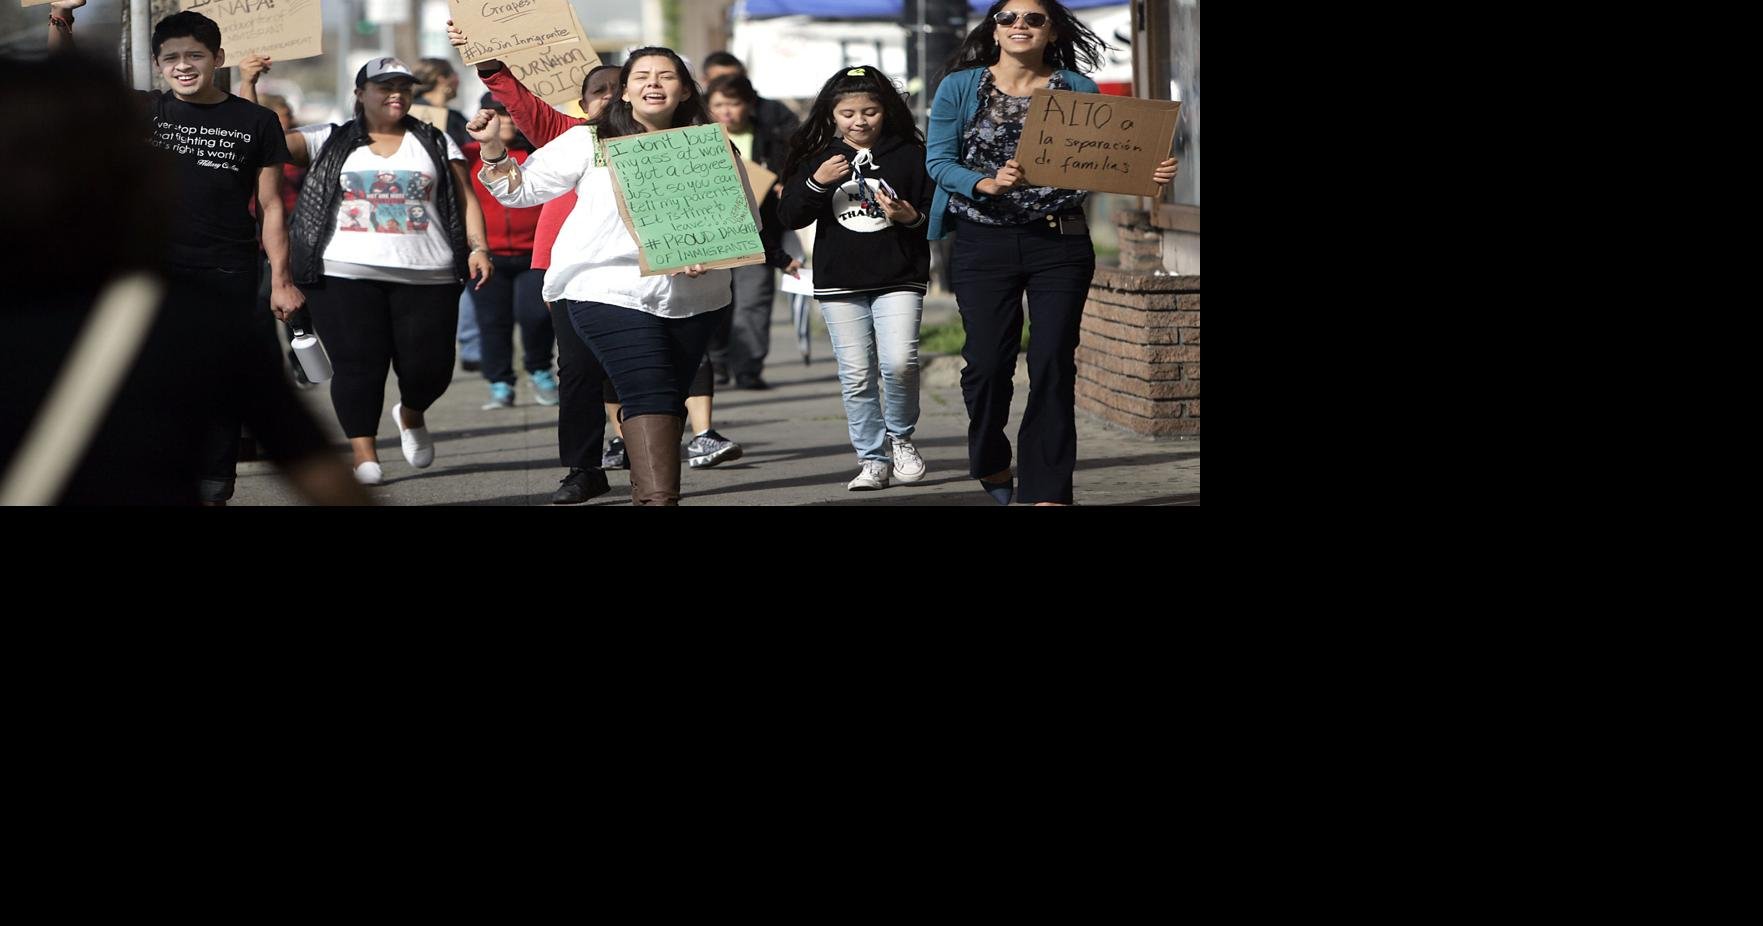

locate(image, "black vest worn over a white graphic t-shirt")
[[289, 116, 471, 286]]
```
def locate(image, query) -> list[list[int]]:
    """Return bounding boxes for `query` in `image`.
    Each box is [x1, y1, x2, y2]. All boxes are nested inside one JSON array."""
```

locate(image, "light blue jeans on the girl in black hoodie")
[[820, 293, 924, 460]]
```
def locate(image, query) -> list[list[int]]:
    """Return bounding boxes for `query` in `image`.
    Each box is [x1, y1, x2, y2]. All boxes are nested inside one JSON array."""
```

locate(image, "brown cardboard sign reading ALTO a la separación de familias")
[[1015, 90, 1181, 196]]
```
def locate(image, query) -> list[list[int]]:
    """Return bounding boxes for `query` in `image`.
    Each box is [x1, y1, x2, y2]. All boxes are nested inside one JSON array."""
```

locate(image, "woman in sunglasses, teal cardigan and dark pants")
[[926, 0, 1176, 504]]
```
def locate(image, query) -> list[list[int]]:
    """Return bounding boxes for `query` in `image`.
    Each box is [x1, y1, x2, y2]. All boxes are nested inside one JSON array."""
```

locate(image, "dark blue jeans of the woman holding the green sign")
[[562, 300, 728, 420]]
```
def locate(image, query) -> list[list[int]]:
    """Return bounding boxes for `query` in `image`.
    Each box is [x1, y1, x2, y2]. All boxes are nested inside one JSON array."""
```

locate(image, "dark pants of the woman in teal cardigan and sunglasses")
[[952, 219, 1097, 504]]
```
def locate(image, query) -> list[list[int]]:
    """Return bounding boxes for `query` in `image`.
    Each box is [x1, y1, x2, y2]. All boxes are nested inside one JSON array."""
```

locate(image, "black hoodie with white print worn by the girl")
[[777, 136, 936, 296]]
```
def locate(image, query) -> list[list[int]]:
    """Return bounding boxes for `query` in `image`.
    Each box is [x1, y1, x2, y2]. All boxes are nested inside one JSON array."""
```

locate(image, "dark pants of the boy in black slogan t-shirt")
[[166, 266, 282, 501]]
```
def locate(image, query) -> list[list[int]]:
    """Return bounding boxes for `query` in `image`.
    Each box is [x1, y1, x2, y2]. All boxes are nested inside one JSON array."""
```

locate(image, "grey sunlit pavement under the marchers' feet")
[[233, 295, 1201, 510]]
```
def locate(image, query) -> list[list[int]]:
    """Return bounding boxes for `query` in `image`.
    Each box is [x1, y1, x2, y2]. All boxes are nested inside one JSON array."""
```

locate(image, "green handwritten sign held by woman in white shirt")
[[601, 123, 765, 277]]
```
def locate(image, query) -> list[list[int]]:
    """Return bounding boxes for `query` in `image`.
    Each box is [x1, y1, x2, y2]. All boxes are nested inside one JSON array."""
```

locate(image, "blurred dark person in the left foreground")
[[0, 53, 368, 506]]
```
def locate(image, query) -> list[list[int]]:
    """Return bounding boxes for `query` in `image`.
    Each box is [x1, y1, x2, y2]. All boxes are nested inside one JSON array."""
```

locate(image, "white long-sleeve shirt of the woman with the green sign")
[[478, 125, 733, 317]]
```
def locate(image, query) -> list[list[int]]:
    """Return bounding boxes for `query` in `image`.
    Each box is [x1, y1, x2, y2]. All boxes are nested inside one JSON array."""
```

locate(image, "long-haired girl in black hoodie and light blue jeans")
[[777, 65, 934, 490]]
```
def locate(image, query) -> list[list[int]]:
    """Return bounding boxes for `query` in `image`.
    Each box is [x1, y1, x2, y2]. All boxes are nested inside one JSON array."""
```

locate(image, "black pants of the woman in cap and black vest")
[[301, 277, 460, 437]]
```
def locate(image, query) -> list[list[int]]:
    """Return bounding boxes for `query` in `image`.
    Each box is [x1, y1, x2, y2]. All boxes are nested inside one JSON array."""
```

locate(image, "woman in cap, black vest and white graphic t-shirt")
[[287, 58, 490, 485]]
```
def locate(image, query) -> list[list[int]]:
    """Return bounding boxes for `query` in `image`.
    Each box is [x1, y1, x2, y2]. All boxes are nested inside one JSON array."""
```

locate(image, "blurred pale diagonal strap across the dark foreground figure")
[[0, 273, 164, 504]]
